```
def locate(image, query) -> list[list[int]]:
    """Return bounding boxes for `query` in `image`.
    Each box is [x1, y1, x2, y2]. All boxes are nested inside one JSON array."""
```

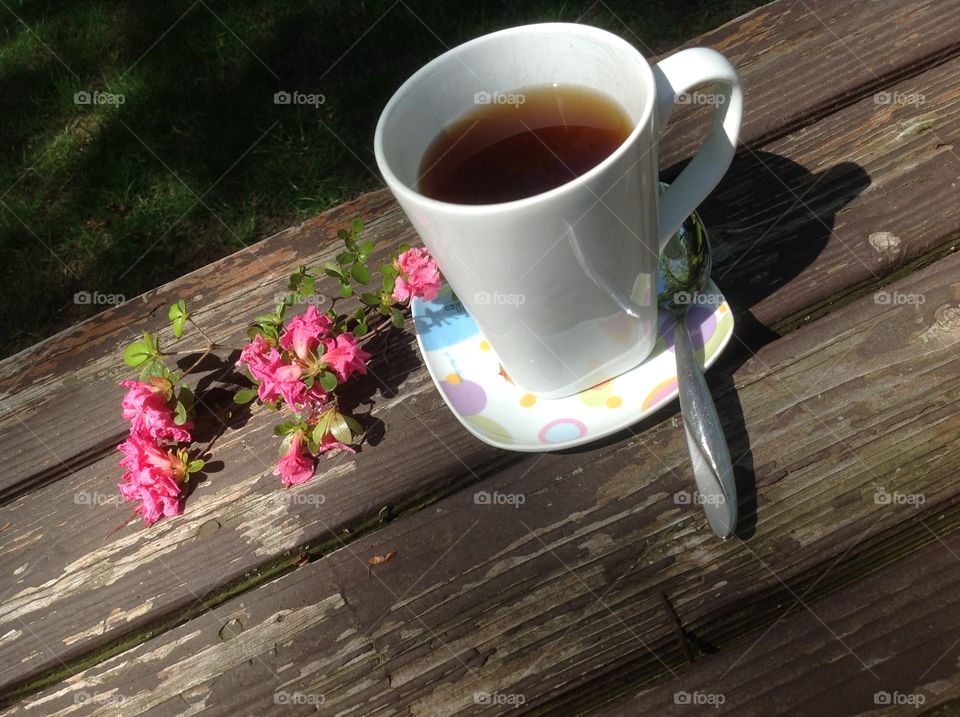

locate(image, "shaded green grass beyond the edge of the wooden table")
[[0, 0, 762, 356]]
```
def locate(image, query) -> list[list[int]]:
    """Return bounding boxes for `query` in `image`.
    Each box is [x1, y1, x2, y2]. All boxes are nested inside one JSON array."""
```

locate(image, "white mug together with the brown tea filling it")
[[374, 23, 743, 398]]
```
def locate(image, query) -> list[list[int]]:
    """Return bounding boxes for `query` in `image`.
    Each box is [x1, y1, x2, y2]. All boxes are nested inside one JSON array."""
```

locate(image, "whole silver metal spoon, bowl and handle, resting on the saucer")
[[657, 207, 737, 539]]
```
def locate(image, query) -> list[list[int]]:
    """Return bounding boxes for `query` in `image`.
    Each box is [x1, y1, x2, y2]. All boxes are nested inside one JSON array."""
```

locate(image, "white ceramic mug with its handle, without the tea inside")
[[374, 23, 743, 398]]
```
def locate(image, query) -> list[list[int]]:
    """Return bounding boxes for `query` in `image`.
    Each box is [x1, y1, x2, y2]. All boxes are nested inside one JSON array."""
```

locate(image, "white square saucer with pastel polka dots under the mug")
[[411, 282, 733, 451]]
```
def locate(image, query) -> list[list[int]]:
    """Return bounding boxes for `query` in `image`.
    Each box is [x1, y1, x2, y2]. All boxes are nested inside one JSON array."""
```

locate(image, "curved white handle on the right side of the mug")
[[652, 47, 743, 251]]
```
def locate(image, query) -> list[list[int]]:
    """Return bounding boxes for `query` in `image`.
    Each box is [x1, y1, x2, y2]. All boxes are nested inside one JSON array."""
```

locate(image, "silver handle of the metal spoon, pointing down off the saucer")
[[673, 315, 737, 539]]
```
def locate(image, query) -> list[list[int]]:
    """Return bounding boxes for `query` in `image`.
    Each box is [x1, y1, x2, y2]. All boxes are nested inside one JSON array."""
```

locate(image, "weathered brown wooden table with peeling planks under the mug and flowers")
[[0, 0, 960, 715]]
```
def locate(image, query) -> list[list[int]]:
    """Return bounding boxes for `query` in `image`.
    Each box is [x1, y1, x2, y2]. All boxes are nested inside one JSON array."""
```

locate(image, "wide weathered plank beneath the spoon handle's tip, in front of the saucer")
[[5, 217, 960, 715]]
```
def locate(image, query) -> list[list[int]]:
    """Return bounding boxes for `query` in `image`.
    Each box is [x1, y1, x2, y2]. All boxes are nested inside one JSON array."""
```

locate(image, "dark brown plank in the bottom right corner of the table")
[[598, 524, 960, 716]]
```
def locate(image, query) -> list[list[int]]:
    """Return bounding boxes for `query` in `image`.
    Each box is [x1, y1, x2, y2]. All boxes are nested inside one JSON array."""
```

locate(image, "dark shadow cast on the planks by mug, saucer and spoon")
[[560, 150, 870, 538]]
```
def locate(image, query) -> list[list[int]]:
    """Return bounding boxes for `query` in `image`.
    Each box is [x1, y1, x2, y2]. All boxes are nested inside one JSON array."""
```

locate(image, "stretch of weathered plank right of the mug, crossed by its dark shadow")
[[702, 60, 960, 330]]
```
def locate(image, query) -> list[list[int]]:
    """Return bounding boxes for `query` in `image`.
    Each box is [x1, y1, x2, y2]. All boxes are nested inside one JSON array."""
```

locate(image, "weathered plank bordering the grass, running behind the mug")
[[0, 0, 960, 501]]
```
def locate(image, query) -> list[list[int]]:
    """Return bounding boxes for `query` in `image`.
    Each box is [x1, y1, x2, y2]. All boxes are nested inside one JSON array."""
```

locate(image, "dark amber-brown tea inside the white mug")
[[417, 87, 633, 204]]
